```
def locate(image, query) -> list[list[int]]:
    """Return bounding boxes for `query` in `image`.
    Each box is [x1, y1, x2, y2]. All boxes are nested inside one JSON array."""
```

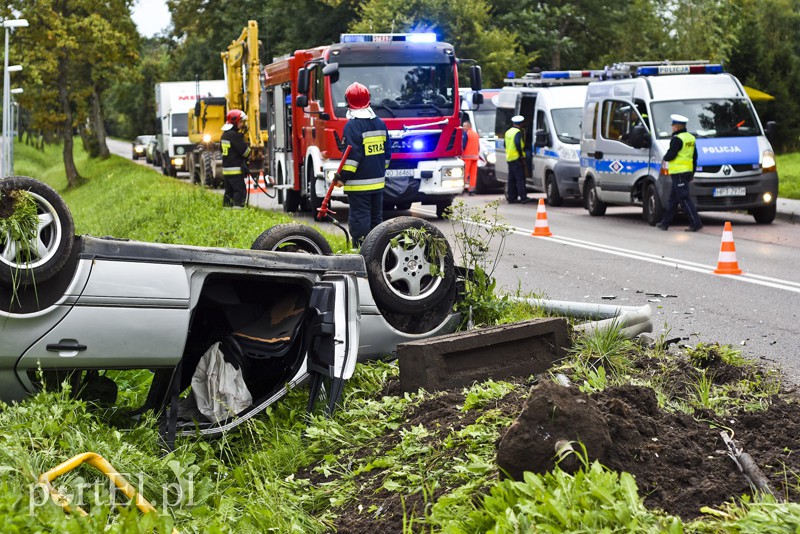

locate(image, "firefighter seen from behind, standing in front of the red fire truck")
[[336, 82, 392, 246]]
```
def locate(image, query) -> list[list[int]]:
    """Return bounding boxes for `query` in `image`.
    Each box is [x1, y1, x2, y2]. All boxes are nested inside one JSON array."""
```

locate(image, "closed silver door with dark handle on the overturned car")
[[17, 258, 190, 383]]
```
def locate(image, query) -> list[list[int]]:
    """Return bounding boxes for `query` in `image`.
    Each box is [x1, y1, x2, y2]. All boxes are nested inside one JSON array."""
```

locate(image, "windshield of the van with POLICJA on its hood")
[[650, 98, 762, 139]]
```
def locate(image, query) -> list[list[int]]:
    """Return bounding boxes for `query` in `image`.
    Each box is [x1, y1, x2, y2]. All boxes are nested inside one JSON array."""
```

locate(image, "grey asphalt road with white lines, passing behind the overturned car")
[[110, 143, 800, 384]]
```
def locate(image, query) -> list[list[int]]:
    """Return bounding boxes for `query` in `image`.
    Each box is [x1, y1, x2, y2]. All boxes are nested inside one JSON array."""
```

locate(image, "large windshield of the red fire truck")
[[331, 64, 456, 118]]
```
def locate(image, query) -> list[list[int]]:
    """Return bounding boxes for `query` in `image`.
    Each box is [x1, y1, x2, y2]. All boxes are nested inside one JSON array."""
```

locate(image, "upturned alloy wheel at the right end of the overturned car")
[[361, 217, 455, 314]]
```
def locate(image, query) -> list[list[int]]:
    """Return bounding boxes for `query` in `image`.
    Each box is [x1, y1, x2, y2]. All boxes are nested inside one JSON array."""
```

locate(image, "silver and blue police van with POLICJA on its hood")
[[579, 61, 778, 225]]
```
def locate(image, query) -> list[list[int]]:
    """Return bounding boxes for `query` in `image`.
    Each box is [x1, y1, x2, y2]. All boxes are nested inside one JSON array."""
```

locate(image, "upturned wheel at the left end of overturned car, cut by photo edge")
[[0, 176, 75, 286]]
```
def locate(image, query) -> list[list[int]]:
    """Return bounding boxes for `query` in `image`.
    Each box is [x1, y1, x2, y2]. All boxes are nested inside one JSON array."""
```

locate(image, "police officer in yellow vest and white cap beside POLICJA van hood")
[[656, 115, 703, 232]]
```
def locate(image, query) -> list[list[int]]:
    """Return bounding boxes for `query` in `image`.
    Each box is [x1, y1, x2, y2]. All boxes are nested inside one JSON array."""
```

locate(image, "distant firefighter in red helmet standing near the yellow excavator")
[[219, 109, 250, 208]]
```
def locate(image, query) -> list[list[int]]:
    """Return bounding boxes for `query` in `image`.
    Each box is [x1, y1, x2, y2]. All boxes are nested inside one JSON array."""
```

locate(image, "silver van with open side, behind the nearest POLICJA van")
[[495, 70, 601, 206]]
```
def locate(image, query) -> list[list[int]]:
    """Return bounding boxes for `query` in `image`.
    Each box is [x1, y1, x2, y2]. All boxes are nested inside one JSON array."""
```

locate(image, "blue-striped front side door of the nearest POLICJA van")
[[595, 99, 650, 203]]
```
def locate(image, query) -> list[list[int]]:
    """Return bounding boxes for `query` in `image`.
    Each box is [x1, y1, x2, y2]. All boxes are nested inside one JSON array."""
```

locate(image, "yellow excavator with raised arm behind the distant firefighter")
[[188, 20, 269, 187]]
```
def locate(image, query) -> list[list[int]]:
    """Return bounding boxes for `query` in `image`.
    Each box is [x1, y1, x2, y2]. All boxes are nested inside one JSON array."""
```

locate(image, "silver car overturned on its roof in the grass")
[[0, 177, 458, 442]]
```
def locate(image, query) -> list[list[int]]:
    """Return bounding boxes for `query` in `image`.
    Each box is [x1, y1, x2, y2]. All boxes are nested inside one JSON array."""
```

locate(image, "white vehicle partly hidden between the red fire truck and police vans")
[[458, 89, 500, 193]]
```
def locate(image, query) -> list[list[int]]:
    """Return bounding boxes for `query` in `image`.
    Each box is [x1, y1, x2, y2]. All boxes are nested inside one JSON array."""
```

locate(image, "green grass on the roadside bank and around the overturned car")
[[0, 140, 800, 533]]
